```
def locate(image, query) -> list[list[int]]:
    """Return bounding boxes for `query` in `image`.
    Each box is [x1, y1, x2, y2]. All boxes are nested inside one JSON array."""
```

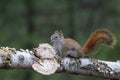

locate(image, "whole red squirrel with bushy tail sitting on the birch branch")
[[51, 29, 116, 58]]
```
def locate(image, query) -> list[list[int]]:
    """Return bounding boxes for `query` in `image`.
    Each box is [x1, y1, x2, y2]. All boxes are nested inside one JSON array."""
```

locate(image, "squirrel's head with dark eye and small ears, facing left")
[[50, 30, 64, 43]]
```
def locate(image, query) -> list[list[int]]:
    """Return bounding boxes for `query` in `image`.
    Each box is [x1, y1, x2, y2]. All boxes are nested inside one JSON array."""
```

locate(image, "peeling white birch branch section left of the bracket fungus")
[[0, 47, 37, 69]]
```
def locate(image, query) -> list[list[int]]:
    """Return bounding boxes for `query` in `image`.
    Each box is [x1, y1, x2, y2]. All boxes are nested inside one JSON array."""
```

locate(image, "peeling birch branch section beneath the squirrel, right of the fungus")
[[57, 58, 120, 79]]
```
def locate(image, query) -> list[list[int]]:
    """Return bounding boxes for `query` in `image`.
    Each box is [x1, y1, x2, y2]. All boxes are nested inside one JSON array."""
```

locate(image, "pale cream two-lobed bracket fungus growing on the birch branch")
[[32, 44, 60, 75]]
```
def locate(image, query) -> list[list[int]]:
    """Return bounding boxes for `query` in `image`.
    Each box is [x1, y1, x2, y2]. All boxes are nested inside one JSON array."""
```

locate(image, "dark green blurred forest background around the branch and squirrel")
[[0, 0, 120, 80]]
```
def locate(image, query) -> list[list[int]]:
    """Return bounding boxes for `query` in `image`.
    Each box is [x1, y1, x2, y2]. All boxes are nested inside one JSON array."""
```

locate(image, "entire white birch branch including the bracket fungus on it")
[[0, 44, 120, 80]]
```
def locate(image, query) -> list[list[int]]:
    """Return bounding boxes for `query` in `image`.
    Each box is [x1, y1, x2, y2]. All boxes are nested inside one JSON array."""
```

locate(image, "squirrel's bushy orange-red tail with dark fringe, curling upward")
[[82, 29, 116, 55]]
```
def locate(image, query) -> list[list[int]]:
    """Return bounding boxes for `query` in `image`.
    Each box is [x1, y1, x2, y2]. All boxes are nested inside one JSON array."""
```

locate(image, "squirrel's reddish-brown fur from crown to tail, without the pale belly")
[[51, 29, 116, 58]]
